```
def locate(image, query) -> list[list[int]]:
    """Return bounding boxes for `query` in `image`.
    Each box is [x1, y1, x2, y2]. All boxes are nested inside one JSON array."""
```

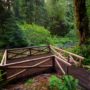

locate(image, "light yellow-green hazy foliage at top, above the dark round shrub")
[[46, 0, 67, 21]]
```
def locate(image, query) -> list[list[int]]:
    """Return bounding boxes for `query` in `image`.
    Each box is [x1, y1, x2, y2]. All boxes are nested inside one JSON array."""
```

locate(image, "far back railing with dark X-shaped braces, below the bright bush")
[[7, 46, 50, 60]]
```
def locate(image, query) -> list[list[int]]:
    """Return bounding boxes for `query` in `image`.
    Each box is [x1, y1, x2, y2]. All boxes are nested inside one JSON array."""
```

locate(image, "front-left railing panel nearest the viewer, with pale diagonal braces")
[[4, 55, 53, 81]]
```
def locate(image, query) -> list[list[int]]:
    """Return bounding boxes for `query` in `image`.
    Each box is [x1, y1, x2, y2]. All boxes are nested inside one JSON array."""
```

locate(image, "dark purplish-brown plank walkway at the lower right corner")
[[69, 67, 90, 90]]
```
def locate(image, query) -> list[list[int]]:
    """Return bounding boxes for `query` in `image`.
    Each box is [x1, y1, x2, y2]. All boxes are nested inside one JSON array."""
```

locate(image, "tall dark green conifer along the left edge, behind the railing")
[[0, 0, 26, 48]]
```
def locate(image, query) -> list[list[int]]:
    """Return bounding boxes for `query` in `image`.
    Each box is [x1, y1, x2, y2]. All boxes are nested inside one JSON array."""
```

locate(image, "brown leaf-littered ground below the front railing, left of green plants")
[[3, 74, 54, 90]]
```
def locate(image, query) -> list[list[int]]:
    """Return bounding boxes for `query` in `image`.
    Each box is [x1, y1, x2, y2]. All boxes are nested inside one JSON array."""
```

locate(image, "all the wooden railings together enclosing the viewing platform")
[[0, 45, 84, 80]]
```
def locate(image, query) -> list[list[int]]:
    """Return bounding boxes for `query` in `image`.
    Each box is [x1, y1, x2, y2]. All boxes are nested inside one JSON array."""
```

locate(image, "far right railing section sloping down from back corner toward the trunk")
[[50, 45, 84, 66]]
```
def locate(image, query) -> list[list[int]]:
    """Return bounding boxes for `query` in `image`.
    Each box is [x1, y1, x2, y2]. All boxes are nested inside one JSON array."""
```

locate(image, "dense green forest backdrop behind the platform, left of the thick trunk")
[[0, 0, 77, 48]]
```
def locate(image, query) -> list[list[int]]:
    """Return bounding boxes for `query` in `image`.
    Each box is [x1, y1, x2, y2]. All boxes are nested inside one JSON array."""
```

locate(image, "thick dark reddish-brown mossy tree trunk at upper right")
[[74, 0, 90, 45]]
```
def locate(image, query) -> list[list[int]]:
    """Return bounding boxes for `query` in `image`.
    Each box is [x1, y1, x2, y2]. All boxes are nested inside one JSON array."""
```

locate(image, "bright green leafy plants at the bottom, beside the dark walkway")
[[49, 75, 78, 90]]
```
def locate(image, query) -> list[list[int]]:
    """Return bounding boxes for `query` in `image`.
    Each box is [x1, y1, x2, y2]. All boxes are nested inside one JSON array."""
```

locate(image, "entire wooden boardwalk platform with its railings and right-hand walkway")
[[0, 46, 90, 90]]
